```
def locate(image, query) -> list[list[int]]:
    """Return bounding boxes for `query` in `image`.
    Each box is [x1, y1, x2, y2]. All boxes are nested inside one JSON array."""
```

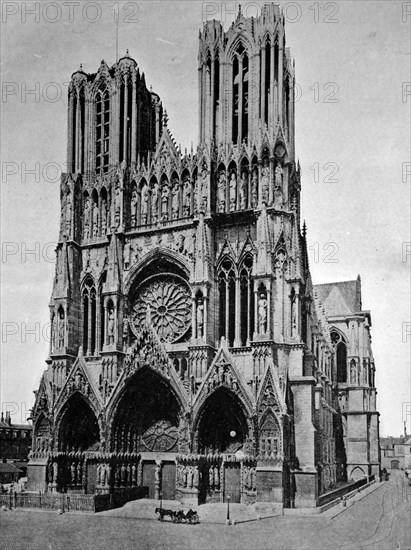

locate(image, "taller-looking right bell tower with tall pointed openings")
[[198, 4, 294, 155]]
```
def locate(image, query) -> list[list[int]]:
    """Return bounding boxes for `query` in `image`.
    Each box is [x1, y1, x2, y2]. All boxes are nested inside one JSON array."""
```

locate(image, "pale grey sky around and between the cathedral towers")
[[0, 0, 411, 437]]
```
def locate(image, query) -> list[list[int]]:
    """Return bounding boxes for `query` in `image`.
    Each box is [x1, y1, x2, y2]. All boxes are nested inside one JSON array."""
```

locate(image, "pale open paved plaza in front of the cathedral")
[[0, 471, 411, 550]]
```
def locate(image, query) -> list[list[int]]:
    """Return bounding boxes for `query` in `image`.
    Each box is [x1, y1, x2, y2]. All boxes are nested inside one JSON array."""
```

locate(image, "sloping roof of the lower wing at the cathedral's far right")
[[314, 275, 362, 317]]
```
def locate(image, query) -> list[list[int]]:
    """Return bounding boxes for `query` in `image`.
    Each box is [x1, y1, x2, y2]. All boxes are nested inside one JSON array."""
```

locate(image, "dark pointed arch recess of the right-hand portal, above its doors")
[[198, 388, 248, 454]]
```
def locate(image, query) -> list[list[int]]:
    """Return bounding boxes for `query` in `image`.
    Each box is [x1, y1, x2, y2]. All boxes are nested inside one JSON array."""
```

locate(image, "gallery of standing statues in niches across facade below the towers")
[[62, 158, 284, 240]]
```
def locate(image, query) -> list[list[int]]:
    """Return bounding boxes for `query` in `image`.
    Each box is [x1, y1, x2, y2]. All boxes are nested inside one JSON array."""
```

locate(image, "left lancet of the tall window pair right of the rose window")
[[218, 258, 236, 346]]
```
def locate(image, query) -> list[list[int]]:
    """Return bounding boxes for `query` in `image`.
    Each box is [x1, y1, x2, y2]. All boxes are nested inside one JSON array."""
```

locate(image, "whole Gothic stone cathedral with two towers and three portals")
[[28, 4, 380, 508]]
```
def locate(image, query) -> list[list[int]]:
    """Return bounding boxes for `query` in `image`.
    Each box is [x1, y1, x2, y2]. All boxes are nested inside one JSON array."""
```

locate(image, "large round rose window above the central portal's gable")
[[132, 273, 191, 342]]
